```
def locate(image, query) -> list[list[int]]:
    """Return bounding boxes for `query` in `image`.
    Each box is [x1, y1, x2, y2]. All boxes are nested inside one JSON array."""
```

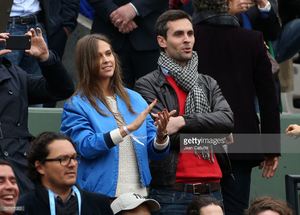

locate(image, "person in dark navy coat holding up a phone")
[[0, 29, 74, 193]]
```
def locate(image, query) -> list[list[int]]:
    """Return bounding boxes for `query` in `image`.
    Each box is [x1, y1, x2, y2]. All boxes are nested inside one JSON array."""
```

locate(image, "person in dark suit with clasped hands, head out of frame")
[[89, 0, 169, 88]]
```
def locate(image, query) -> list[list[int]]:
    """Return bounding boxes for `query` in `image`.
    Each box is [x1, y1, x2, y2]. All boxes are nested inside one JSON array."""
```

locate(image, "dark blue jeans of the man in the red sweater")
[[149, 188, 223, 215]]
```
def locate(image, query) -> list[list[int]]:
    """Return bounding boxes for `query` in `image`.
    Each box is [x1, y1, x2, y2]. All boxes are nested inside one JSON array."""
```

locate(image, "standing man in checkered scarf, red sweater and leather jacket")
[[135, 10, 233, 215]]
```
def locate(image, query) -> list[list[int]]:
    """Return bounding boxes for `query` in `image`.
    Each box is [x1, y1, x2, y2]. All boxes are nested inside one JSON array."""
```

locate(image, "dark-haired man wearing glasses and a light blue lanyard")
[[16, 132, 113, 215]]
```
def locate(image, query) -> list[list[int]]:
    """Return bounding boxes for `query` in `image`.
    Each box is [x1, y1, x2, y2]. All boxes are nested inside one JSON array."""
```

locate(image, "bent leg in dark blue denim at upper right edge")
[[273, 19, 300, 63]]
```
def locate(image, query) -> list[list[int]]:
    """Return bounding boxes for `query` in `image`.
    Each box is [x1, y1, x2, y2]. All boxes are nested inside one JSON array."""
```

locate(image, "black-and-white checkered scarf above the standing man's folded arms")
[[158, 52, 211, 114]]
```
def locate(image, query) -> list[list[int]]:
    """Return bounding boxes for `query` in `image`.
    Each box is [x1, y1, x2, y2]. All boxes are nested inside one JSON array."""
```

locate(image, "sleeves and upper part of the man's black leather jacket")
[[135, 71, 233, 150]]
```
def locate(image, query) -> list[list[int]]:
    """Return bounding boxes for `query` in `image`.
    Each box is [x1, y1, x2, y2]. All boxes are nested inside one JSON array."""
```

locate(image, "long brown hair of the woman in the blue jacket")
[[76, 34, 135, 116]]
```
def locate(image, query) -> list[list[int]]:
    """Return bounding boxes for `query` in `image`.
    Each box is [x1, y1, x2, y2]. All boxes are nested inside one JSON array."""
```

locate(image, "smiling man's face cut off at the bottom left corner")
[[0, 160, 19, 215]]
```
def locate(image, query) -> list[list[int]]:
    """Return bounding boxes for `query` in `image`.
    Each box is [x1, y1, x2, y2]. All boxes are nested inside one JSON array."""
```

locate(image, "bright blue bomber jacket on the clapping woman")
[[61, 89, 169, 197]]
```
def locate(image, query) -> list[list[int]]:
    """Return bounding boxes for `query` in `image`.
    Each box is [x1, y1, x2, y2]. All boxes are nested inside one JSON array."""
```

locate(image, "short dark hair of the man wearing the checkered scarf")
[[155, 10, 192, 38]]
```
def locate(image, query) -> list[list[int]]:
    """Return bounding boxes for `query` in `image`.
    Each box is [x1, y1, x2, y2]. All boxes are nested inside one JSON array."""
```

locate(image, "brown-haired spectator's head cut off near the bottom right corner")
[[245, 197, 293, 215]]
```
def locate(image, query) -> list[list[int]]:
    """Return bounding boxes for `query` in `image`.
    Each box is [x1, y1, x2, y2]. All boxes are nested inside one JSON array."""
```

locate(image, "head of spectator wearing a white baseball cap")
[[110, 193, 160, 215]]
